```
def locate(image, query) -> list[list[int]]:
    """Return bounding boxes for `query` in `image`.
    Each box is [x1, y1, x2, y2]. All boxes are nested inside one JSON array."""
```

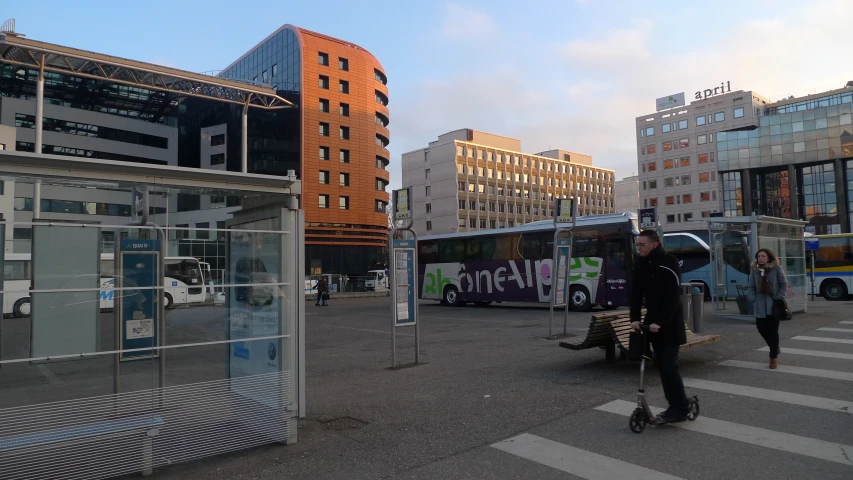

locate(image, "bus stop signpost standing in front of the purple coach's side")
[[548, 197, 577, 339]]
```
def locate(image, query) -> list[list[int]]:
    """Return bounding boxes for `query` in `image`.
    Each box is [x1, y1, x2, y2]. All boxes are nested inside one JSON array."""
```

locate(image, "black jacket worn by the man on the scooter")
[[631, 246, 687, 345]]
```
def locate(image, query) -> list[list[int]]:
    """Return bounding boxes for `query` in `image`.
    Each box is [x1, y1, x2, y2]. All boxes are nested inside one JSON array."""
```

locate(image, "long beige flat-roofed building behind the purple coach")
[[402, 129, 615, 235]]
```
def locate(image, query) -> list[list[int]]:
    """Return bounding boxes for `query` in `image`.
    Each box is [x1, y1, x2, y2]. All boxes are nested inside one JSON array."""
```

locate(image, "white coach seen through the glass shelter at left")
[[3, 253, 206, 317]]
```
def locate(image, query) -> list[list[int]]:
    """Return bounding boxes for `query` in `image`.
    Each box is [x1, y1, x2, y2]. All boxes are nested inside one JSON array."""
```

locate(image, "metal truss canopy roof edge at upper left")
[[0, 33, 295, 110]]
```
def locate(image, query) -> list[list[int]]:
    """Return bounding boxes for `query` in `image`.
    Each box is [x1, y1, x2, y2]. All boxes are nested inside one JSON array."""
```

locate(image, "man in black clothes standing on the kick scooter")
[[631, 230, 690, 424]]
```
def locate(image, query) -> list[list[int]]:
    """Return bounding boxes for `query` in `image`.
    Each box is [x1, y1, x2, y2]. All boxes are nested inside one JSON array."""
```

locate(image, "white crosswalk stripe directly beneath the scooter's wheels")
[[596, 400, 853, 467]]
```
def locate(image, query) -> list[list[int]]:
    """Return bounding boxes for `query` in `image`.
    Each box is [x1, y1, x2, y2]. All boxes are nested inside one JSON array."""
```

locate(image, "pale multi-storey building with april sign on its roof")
[[636, 87, 770, 231]]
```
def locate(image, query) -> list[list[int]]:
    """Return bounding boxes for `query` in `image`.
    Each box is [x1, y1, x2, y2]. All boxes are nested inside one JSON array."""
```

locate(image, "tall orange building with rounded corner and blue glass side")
[[220, 25, 390, 274]]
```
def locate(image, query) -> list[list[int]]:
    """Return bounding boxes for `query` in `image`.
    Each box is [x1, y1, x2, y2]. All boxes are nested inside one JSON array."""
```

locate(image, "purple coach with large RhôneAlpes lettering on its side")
[[418, 213, 639, 311]]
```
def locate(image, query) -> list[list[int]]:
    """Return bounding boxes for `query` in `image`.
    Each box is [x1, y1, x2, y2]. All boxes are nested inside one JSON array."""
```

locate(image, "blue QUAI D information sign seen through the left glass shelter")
[[116, 239, 160, 361]]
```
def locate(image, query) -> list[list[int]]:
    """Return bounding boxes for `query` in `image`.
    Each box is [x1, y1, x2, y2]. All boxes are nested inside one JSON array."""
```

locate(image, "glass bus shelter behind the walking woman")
[[703, 215, 808, 318]]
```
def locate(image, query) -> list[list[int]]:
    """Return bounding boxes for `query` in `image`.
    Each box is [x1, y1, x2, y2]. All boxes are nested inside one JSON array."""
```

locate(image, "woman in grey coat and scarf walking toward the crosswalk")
[[749, 248, 788, 368]]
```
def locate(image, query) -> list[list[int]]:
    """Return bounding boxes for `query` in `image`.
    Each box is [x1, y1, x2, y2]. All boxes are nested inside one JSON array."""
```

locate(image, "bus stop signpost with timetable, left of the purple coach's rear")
[[388, 187, 420, 368]]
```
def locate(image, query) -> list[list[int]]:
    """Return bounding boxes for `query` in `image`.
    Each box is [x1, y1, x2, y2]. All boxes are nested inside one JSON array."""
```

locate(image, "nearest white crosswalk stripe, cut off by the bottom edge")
[[492, 433, 681, 480]]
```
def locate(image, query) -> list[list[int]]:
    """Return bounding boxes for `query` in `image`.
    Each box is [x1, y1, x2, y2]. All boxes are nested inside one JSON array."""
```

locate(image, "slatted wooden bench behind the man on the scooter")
[[560, 309, 720, 363]]
